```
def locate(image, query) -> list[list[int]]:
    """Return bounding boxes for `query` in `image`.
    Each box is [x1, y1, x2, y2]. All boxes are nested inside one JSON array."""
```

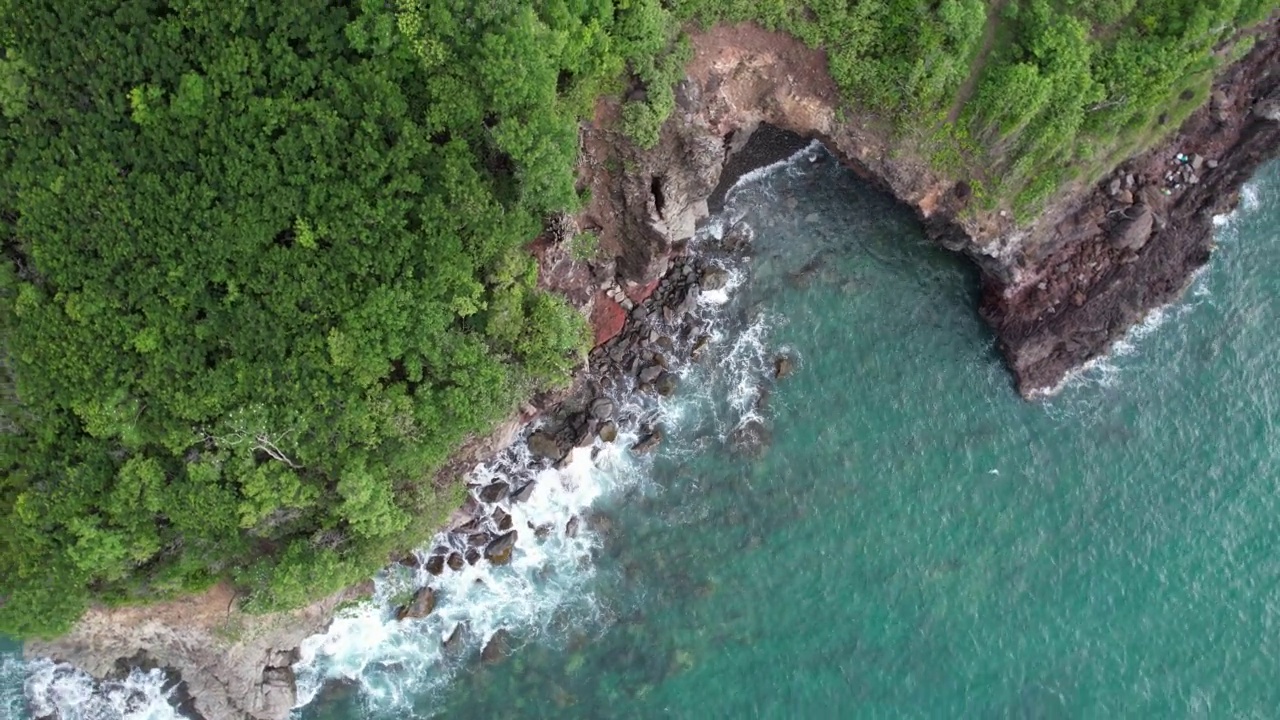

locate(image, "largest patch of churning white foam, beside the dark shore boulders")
[[294, 436, 643, 716]]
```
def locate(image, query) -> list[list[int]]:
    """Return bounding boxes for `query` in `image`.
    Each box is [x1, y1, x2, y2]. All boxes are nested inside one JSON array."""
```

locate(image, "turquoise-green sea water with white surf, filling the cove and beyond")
[[0, 149, 1280, 720]]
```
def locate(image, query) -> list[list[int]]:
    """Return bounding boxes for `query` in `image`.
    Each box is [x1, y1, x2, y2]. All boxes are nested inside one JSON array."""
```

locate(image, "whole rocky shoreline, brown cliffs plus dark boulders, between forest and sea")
[[26, 22, 1280, 720]]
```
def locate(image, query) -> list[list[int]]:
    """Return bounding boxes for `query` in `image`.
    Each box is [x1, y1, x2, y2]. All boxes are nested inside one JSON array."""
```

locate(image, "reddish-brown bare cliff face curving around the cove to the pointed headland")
[[581, 23, 1280, 397]]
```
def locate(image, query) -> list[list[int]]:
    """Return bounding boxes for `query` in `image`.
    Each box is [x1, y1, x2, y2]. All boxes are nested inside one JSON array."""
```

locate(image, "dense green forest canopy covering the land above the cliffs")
[[0, 0, 1276, 637]]
